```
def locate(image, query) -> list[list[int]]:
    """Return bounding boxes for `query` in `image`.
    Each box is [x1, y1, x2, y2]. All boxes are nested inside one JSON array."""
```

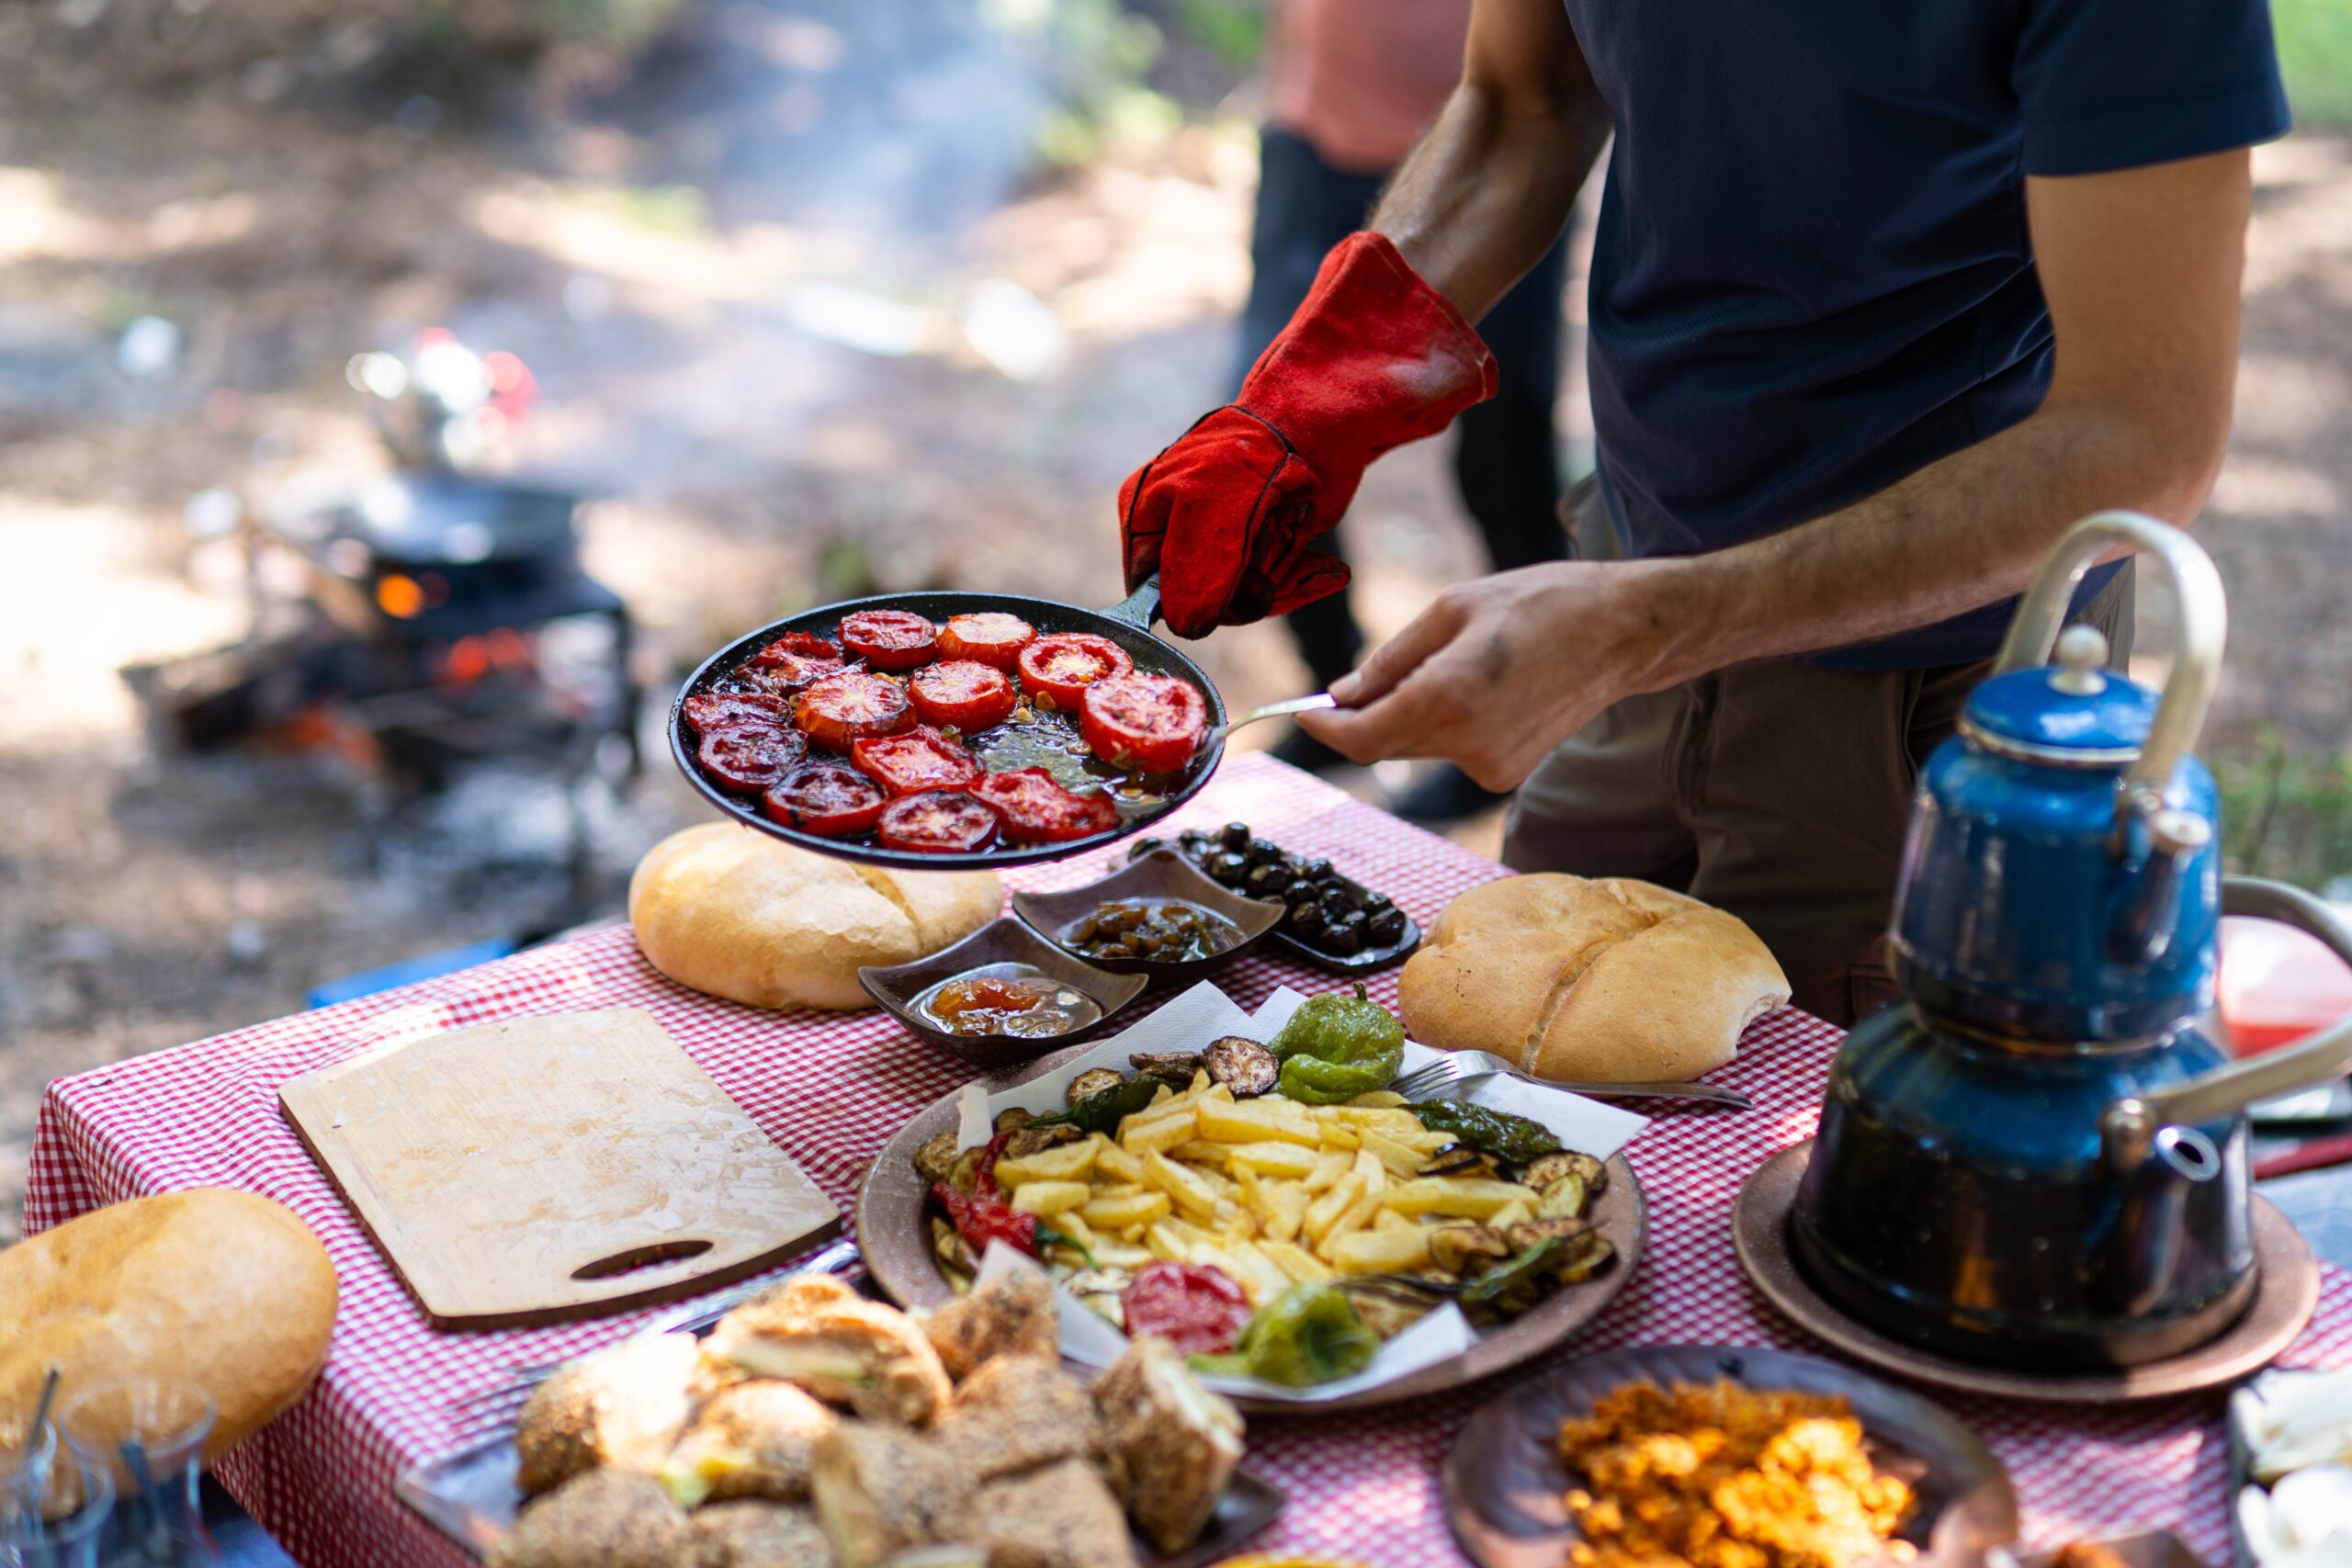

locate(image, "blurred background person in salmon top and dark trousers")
[[1235, 0, 1569, 820]]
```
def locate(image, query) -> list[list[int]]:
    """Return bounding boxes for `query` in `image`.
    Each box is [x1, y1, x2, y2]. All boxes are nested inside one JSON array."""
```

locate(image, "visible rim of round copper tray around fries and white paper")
[[858, 1046, 1649, 1416]]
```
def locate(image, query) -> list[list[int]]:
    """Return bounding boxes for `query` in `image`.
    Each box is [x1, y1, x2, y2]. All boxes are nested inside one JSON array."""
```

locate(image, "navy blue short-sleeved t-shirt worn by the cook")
[[1566, 0, 2286, 668]]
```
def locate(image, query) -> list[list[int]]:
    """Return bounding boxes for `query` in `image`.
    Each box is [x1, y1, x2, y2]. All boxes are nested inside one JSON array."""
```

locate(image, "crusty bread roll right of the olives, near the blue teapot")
[[1397, 872, 1788, 1084]]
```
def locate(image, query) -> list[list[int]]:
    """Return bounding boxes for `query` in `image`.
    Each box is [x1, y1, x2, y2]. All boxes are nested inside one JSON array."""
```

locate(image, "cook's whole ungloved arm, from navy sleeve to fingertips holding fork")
[[1306, 151, 2251, 787]]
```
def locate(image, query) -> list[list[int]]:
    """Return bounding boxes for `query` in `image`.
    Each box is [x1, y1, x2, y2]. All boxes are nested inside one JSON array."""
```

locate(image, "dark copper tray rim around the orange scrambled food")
[[1440, 1345, 2018, 1568]]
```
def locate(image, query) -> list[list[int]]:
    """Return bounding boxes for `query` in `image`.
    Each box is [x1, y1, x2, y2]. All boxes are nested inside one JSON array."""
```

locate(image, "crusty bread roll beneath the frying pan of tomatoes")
[[628, 823, 1004, 1013]]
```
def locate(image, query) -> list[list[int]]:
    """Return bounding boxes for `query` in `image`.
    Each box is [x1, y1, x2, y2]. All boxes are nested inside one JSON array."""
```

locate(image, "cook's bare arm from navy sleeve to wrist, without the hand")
[[1627, 151, 2251, 684]]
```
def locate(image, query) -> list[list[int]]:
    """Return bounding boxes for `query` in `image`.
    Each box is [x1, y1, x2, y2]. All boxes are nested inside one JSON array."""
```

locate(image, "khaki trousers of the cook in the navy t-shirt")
[[1503, 479, 2133, 1025]]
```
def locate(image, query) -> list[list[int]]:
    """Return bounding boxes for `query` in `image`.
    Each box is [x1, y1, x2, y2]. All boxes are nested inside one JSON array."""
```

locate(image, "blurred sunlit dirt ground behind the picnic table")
[[0, 3, 2352, 1241]]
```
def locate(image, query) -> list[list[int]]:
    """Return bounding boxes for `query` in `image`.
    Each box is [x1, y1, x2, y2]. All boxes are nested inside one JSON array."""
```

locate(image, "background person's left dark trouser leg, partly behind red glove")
[[1232, 127, 1385, 686]]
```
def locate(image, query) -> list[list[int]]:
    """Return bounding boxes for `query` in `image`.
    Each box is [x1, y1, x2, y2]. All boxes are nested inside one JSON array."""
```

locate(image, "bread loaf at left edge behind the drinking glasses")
[[0, 1187, 336, 1462]]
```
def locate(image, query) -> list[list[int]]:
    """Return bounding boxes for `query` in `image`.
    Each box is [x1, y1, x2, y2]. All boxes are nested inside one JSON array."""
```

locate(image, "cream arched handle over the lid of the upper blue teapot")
[[1992, 513, 2230, 813]]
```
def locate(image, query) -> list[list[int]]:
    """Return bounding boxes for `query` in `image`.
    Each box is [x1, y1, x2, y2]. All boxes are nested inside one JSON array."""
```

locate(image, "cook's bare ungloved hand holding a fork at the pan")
[[1298, 562, 1675, 790]]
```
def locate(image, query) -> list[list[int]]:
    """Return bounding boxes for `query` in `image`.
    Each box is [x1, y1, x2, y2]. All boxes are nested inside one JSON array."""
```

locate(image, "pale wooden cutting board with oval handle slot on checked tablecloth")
[[277, 1009, 842, 1328]]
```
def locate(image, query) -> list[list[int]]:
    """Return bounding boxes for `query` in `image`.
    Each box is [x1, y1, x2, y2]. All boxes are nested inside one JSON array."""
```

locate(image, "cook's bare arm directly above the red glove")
[[1371, 0, 1609, 322]]
